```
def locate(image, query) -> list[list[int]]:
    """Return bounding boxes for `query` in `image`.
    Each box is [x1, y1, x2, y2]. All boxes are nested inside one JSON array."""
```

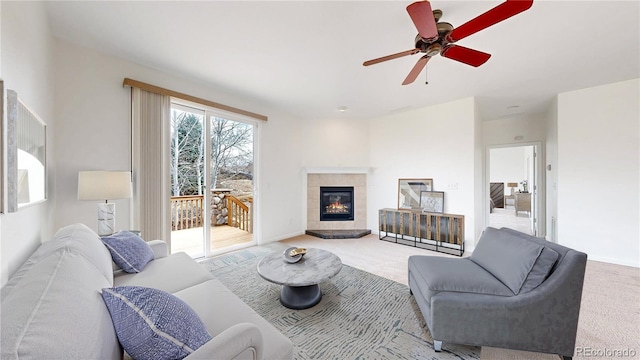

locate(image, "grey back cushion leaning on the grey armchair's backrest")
[[470, 227, 544, 295]]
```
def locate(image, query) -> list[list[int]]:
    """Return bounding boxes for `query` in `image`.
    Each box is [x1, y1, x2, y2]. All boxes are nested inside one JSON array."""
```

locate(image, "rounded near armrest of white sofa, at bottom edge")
[[185, 323, 263, 360]]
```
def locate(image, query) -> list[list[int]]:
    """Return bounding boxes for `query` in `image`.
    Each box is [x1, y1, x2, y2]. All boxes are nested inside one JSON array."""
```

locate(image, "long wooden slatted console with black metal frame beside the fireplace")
[[378, 209, 464, 256]]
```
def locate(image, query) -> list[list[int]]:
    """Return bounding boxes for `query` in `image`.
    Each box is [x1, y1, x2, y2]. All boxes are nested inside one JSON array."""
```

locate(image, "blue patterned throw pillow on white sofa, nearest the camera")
[[102, 286, 211, 360]]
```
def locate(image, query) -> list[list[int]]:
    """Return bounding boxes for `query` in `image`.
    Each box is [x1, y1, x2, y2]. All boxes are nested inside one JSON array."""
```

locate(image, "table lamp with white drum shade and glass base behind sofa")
[[78, 171, 131, 236]]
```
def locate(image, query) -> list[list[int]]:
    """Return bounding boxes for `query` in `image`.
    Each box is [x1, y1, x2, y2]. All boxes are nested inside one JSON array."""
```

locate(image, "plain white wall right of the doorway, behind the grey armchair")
[[558, 79, 640, 267]]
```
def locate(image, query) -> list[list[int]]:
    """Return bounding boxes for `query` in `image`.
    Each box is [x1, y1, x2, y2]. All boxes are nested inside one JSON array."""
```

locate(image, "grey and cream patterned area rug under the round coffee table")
[[202, 244, 480, 360]]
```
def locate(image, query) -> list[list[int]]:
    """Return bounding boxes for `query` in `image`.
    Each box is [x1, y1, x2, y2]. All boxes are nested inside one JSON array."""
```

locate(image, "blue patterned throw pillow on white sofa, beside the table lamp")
[[102, 231, 154, 273]]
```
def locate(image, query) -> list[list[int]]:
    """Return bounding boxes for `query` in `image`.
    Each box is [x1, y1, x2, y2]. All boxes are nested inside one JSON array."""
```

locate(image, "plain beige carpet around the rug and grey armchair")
[[282, 234, 640, 360]]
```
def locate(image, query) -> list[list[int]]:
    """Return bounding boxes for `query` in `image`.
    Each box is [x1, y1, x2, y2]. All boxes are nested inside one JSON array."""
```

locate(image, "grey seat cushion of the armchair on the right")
[[409, 255, 513, 300]]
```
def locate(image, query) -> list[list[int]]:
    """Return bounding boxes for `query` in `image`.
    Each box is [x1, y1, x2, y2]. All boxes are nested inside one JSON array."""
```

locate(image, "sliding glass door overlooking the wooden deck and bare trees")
[[170, 100, 257, 258]]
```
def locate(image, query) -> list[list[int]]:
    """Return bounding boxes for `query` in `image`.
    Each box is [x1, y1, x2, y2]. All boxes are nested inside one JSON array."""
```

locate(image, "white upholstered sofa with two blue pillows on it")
[[0, 224, 293, 360]]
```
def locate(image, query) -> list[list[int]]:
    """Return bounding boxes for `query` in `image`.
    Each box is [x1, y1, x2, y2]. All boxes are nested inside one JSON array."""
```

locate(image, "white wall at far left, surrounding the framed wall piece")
[[0, 2, 57, 284]]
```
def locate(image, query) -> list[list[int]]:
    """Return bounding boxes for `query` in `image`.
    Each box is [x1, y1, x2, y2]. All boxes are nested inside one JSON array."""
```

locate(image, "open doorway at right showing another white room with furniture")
[[485, 143, 544, 236]]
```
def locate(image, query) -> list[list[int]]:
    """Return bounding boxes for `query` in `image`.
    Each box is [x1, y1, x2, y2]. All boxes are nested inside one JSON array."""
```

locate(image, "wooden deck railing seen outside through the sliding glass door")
[[171, 195, 253, 232]]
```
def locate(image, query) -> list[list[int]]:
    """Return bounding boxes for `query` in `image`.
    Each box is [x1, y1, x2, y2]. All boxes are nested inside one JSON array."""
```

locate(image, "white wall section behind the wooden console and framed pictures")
[[367, 98, 478, 250]]
